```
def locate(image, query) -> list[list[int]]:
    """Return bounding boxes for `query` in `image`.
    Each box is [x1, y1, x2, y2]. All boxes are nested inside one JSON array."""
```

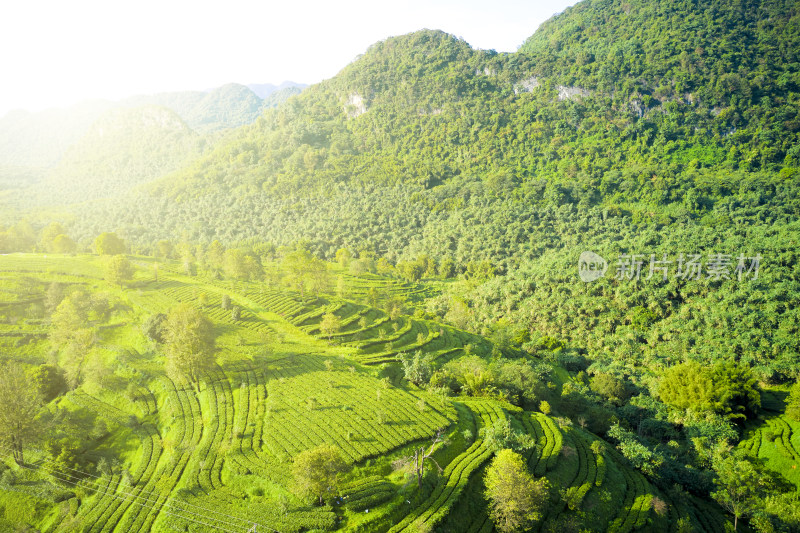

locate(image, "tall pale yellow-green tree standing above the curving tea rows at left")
[[164, 303, 214, 385]]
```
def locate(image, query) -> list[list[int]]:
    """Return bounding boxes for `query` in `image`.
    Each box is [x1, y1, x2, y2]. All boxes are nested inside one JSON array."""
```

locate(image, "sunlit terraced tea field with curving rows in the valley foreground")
[[0, 255, 728, 533]]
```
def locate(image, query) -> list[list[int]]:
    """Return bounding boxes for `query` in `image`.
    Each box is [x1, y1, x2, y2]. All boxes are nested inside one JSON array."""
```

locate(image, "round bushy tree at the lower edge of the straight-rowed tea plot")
[[292, 444, 347, 505]]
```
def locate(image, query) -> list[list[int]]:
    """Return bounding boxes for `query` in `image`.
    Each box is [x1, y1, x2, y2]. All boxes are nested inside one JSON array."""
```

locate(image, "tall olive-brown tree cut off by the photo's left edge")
[[0, 362, 42, 465]]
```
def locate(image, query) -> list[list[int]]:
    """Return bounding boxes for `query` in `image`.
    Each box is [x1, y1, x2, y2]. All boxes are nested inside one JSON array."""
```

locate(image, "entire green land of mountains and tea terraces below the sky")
[[0, 0, 800, 533]]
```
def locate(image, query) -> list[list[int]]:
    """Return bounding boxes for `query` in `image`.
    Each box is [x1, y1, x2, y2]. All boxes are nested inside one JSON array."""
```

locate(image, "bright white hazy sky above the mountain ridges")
[[0, 0, 577, 116]]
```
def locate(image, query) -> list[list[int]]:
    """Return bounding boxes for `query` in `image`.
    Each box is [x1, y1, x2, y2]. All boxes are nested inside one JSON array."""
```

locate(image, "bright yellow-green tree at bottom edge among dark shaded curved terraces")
[[484, 449, 549, 533]]
